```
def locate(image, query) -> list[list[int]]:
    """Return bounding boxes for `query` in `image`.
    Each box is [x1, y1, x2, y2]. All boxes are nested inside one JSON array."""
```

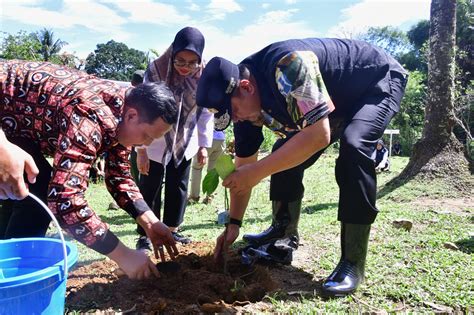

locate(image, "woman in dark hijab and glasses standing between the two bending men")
[[137, 27, 214, 250]]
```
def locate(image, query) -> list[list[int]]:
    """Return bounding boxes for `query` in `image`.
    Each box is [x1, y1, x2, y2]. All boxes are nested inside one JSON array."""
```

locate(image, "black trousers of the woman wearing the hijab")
[[137, 159, 191, 235]]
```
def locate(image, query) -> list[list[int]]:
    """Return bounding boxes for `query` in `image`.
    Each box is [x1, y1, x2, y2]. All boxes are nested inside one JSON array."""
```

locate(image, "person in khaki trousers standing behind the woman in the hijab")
[[188, 130, 225, 204]]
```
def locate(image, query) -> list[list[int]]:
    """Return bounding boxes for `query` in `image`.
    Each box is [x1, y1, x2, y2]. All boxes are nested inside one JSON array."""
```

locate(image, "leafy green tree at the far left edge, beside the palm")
[[0, 31, 41, 61]]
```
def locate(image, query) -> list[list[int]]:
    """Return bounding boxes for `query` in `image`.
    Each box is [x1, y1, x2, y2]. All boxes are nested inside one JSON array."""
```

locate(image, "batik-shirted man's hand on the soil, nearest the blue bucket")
[[107, 242, 160, 280]]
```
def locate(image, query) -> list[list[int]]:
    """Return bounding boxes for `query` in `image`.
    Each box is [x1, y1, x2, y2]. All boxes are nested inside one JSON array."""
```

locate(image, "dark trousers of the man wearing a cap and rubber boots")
[[270, 73, 406, 224]]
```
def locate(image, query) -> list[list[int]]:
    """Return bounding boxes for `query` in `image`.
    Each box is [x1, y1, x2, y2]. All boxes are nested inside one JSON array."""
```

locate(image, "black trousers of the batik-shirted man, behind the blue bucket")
[[0, 138, 52, 239]]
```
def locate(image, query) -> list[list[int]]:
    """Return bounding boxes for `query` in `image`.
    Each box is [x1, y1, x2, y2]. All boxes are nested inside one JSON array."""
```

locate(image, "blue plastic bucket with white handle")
[[0, 194, 77, 315]]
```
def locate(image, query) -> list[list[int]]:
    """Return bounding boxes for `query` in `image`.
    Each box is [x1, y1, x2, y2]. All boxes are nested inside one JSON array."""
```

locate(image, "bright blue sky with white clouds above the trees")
[[0, 0, 430, 62]]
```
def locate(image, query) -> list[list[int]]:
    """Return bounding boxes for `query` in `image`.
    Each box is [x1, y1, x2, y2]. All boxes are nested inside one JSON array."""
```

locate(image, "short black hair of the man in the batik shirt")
[[125, 83, 178, 125]]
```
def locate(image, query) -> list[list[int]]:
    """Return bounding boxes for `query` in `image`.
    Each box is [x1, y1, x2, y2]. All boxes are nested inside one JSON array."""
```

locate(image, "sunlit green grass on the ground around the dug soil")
[[79, 154, 474, 313]]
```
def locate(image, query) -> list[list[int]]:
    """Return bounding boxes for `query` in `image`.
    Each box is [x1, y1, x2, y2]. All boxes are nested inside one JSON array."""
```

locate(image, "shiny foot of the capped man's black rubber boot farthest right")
[[322, 260, 364, 297]]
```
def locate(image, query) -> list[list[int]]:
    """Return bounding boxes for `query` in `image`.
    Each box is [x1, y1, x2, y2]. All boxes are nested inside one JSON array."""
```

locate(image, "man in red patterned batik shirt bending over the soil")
[[0, 60, 177, 278]]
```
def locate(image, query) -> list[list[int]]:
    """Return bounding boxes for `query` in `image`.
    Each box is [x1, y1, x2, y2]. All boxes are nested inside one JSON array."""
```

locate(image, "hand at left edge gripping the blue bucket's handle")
[[0, 130, 39, 200]]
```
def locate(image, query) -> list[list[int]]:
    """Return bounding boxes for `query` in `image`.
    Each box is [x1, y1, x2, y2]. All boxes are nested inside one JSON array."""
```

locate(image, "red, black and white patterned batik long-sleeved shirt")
[[0, 60, 145, 254]]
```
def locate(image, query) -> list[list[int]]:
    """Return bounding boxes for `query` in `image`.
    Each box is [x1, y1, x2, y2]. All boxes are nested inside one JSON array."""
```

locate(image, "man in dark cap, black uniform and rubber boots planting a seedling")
[[197, 38, 407, 296]]
